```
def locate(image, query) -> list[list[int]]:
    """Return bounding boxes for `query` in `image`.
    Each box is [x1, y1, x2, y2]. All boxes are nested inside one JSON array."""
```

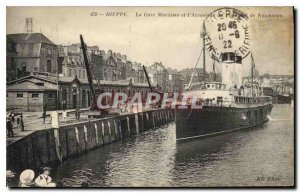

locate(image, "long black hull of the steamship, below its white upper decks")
[[175, 104, 273, 141]]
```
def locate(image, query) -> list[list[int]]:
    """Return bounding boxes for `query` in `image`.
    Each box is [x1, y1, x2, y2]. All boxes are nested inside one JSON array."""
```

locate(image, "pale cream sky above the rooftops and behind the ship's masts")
[[6, 7, 294, 75]]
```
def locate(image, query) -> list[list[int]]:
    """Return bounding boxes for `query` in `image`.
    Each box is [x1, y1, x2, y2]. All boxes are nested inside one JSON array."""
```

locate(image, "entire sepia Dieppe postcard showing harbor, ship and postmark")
[[6, 6, 295, 188]]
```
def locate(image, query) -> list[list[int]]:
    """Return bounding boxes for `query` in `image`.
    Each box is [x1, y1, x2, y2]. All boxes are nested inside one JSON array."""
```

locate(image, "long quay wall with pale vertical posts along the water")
[[6, 109, 175, 172]]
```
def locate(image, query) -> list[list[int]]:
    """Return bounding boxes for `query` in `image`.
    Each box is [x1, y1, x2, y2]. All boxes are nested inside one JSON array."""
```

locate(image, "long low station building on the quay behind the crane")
[[6, 73, 150, 112]]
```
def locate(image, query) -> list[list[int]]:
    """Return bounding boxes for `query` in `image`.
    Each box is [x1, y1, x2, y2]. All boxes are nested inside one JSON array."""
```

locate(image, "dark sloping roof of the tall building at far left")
[[7, 33, 55, 45]]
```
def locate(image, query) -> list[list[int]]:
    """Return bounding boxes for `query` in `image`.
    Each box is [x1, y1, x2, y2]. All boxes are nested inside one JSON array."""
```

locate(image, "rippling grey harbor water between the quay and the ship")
[[51, 105, 294, 187]]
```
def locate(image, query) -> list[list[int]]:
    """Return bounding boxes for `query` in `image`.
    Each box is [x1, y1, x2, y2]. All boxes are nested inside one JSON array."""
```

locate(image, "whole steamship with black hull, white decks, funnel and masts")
[[175, 25, 273, 141]]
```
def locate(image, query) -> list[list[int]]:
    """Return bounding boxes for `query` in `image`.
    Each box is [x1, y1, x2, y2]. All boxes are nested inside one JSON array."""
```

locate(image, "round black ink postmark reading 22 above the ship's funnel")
[[202, 7, 250, 63]]
